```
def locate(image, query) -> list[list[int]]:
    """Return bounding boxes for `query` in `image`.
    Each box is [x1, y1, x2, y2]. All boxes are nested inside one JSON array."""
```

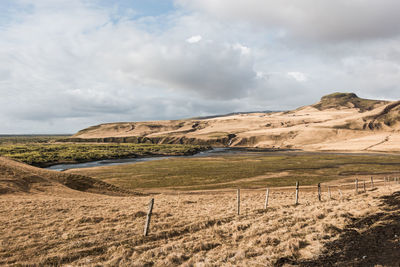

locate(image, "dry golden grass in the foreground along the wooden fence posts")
[[0, 182, 400, 266]]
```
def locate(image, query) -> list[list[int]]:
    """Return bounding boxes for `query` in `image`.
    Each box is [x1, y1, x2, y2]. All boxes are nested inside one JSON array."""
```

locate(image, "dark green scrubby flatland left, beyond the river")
[[0, 137, 207, 167]]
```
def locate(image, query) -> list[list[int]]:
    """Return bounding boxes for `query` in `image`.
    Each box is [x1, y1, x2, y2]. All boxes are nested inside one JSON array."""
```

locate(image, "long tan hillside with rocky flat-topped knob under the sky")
[[73, 93, 400, 151]]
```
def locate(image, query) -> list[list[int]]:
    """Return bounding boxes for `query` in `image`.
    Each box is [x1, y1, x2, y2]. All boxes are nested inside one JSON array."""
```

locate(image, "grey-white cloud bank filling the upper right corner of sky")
[[176, 0, 400, 41]]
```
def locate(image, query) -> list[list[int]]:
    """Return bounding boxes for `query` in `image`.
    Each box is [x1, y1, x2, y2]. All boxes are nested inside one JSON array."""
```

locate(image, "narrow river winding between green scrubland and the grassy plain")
[[46, 147, 390, 171]]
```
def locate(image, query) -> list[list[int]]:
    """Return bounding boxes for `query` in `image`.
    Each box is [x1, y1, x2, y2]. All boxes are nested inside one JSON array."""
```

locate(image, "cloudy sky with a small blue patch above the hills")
[[0, 0, 400, 134]]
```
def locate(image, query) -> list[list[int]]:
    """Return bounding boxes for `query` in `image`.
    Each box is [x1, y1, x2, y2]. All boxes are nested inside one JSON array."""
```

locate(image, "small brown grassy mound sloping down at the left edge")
[[0, 157, 132, 195]]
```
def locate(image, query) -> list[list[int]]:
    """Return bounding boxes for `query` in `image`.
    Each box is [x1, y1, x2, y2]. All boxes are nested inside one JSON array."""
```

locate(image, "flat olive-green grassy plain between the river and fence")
[[68, 152, 400, 190]]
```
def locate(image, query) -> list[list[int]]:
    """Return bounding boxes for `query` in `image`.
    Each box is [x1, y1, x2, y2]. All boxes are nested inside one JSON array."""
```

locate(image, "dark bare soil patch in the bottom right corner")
[[275, 191, 400, 267]]
